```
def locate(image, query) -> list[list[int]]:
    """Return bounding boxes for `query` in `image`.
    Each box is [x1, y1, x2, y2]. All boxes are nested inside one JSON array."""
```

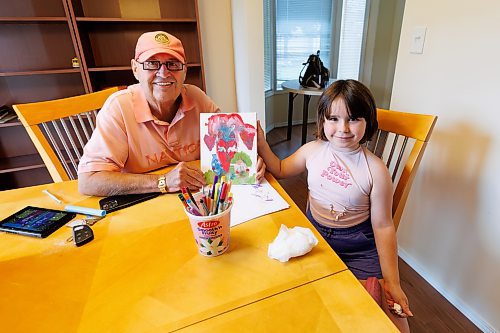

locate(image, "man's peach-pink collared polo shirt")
[[78, 84, 220, 173]]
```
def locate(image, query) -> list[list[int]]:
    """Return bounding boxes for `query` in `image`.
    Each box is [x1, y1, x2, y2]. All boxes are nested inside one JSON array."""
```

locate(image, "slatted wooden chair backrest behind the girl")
[[367, 109, 437, 230]]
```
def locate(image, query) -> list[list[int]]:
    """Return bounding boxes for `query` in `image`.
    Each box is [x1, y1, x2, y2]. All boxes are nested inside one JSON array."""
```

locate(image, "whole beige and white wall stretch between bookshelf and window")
[[198, 0, 265, 126]]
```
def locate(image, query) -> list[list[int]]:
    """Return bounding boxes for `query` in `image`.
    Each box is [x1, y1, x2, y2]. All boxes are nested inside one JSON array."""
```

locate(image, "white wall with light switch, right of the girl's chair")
[[391, 0, 500, 332]]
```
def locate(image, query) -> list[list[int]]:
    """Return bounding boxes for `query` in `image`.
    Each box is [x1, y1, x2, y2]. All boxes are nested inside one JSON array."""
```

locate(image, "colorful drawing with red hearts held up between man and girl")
[[200, 113, 257, 185]]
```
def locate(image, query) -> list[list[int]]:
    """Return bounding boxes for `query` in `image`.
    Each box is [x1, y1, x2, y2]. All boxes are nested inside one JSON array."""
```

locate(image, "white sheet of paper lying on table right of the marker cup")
[[231, 179, 290, 227]]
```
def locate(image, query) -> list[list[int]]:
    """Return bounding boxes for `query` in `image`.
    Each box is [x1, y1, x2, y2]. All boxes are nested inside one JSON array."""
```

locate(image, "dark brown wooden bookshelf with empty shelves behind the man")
[[0, 0, 205, 190]]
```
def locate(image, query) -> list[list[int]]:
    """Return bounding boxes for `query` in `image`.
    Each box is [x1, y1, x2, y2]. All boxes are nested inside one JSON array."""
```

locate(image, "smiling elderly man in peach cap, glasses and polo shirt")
[[78, 31, 265, 196]]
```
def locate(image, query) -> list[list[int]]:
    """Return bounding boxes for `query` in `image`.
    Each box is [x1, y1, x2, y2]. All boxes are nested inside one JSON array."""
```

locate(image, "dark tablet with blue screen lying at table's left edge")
[[0, 206, 76, 238]]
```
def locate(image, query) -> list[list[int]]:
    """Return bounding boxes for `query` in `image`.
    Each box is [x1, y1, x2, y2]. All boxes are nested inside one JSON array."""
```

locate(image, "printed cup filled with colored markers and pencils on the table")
[[179, 176, 233, 257]]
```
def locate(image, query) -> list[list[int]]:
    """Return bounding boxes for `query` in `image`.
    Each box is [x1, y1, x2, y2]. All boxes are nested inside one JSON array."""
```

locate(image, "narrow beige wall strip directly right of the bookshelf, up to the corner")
[[198, 0, 237, 112]]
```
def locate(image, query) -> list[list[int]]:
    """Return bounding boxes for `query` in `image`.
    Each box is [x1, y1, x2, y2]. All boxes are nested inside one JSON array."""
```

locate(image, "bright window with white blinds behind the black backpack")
[[264, 0, 366, 91]]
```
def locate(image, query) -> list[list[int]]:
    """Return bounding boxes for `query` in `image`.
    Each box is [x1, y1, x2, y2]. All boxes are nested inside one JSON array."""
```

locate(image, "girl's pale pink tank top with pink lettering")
[[306, 140, 373, 228]]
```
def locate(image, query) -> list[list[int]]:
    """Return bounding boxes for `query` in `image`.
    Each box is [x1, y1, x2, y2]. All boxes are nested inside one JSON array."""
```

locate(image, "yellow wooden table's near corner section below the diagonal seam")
[[180, 271, 399, 333]]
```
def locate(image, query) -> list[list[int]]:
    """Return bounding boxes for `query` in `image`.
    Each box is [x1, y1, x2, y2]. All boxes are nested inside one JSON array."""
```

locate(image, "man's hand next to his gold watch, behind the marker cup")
[[165, 162, 206, 192]]
